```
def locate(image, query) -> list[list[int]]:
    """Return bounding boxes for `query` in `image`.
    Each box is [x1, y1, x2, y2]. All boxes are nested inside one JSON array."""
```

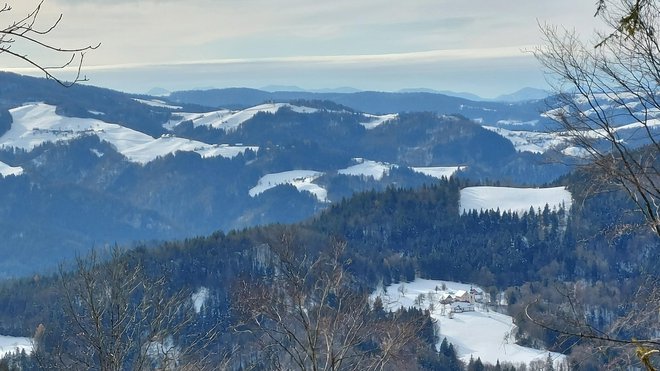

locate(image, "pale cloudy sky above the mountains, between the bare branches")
[[0, 0, 597, 97]]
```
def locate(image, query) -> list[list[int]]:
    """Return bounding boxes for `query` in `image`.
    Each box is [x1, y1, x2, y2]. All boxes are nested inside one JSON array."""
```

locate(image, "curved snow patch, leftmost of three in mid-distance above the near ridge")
[[249, 170, 328, 202]]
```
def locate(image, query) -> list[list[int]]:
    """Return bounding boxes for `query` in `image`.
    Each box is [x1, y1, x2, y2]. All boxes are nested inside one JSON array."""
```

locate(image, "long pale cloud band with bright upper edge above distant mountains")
[[2, 48, 543, 96]]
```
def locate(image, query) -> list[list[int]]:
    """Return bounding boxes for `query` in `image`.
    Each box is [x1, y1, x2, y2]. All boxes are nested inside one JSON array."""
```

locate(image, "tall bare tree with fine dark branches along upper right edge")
[[535, 0, 660, 236]]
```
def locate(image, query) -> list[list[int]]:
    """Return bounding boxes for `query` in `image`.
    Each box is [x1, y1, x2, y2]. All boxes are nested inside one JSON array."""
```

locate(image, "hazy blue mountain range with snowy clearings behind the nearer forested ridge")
[[0, 73, 648, 276]]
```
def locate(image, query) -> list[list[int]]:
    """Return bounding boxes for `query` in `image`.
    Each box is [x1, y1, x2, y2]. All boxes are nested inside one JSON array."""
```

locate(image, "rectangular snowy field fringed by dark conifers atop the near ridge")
[[460, 187, 573, 214]]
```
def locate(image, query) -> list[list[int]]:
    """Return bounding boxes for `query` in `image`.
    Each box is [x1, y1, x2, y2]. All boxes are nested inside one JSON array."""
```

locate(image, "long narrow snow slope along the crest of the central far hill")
[[164, 103, 317, 131]]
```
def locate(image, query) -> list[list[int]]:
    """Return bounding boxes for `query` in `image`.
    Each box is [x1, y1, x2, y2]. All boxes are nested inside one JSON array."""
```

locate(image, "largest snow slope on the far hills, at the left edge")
[[0, 103, 258, 164]]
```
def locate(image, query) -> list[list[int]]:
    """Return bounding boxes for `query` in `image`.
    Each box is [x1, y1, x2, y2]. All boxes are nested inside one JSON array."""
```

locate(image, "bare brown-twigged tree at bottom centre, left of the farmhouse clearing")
[[234, 236, 421, 370]]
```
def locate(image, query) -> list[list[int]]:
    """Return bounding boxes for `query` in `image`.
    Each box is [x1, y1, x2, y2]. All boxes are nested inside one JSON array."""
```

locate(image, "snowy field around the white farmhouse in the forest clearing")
[[371, 278, 565, 370]]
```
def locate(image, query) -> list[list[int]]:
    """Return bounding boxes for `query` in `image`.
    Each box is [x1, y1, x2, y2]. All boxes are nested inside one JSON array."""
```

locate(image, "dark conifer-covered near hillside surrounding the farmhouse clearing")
[[0, 171, 658, 370]]
